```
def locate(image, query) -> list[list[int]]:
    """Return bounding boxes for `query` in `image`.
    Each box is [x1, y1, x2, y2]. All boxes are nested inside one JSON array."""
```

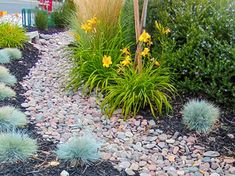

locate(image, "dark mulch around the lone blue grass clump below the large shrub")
[[141, 93, 235, 156]]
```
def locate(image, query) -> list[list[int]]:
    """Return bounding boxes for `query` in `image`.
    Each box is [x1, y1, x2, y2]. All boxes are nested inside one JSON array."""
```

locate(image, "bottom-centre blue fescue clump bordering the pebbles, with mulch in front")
[[56, 135, 101, 164]]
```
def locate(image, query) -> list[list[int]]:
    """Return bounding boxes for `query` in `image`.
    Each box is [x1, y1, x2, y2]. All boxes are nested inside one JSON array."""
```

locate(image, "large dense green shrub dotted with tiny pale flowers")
[[148, 0, 235, 107]]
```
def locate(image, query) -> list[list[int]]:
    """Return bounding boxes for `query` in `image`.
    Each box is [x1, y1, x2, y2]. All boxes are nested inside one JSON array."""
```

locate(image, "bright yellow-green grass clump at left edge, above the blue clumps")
[[0, 23, 28, 48]]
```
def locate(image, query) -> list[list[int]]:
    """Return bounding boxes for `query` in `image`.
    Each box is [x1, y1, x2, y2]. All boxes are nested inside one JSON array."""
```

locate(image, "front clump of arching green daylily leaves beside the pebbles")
[[101, 65, 175, 118]]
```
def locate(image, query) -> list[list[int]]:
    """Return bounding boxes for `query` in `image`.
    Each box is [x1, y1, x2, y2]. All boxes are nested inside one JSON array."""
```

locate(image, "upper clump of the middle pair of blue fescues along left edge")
[[0, 66, 17, 86]]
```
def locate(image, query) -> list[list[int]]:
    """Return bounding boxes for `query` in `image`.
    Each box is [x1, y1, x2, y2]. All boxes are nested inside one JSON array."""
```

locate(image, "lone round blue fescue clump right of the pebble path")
[[183, 100, 220, 133]]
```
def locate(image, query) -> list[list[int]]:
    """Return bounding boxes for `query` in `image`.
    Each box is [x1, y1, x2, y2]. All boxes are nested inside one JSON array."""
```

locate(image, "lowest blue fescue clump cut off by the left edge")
[[0, 132, 38, 163]]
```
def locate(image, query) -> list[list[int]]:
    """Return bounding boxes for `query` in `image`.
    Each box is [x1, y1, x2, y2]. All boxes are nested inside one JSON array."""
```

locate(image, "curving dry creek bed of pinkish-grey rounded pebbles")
[[19, 32, 235, 176]]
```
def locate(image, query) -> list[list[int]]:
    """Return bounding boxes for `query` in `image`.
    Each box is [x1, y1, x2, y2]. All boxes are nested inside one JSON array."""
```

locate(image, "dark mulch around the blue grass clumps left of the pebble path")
[[0, 42, 126, 176]]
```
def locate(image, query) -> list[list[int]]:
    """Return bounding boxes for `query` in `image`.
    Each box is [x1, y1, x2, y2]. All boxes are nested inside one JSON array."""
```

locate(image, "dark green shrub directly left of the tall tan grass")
[[51, 0, 76, 28]]
